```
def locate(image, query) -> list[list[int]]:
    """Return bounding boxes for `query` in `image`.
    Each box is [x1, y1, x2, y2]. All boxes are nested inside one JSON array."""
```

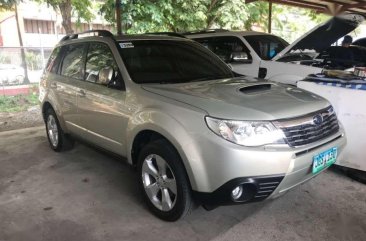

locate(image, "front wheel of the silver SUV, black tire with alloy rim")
[[137, 140, 193, 221]]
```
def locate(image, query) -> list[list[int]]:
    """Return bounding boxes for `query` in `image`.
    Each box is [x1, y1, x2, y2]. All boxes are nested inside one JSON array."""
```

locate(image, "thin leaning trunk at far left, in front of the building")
[[0, 0, 30, 84]]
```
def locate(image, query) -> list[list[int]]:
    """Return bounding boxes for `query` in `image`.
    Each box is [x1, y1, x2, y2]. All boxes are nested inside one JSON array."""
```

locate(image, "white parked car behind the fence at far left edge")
[[0, 64, 24, 85]]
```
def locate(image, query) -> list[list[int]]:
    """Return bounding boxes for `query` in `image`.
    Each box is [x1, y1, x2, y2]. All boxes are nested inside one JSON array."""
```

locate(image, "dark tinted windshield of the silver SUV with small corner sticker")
[[119, 40, 233, 84]]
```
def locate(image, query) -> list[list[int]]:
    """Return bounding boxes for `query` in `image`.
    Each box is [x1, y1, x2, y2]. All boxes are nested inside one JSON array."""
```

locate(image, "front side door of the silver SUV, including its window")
[[78, 42, 128, 154]]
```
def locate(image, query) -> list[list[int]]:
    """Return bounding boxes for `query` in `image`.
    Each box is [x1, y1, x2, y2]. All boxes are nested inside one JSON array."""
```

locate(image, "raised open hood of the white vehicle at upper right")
[[273, 13, 365, 60]]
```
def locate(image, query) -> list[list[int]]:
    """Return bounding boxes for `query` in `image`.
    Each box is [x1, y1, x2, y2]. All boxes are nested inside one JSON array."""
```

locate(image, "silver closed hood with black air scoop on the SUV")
[[142, 77, 329, 120]]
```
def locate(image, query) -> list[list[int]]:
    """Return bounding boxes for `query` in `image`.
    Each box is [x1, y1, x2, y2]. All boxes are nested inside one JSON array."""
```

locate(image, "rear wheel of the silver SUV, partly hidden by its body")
[[45, 108, 74, 152]]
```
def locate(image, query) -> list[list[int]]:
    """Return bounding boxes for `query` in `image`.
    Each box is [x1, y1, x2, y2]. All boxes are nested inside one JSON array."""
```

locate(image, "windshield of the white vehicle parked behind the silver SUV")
[[244, 35, 289, 60]]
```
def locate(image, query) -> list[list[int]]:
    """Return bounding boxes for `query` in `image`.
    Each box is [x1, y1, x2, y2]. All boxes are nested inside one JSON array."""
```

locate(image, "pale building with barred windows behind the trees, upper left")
[[0, 1, 113, 48]]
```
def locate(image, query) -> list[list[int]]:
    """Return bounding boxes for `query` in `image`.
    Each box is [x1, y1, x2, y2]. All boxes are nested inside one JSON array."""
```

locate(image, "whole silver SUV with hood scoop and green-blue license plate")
[[40, 31, 346, 221]]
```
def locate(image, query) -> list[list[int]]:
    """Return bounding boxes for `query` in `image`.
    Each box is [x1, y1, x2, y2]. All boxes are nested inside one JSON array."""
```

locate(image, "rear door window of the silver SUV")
[[61, 44, 86, 80]]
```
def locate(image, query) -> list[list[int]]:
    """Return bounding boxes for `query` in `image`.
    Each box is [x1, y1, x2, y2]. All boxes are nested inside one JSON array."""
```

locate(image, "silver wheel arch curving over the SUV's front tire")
[[126, 110, 207, 190]]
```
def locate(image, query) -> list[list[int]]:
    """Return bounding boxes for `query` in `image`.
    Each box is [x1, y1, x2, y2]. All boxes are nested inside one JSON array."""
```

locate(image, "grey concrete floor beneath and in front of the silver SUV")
[[0, 128, 366, 241]]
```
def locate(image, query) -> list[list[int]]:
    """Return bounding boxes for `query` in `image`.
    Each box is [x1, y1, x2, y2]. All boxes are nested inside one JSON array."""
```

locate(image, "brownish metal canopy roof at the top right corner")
[[245, 0, 366, 15]]
